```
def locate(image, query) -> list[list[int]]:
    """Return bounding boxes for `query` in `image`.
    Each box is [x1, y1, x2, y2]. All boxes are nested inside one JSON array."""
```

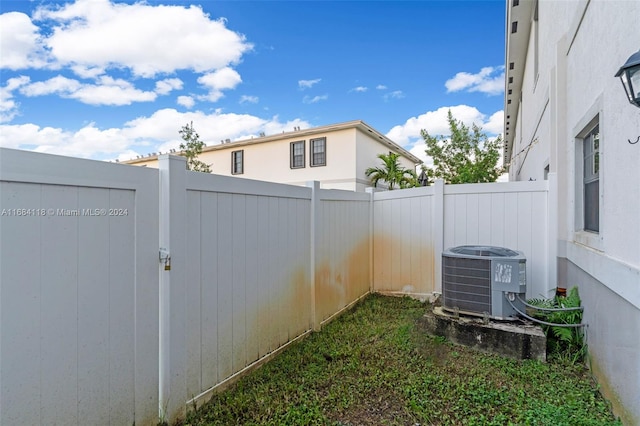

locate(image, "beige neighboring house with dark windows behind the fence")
[[126, 120, 422, 191]]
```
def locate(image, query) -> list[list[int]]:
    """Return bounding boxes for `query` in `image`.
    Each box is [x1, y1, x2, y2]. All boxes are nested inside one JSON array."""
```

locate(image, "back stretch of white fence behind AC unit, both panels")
[[373, 178, 556, 297]]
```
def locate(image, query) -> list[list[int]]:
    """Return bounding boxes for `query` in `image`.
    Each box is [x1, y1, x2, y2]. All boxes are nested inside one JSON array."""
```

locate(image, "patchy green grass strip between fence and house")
[[181, 295, 621, 426]]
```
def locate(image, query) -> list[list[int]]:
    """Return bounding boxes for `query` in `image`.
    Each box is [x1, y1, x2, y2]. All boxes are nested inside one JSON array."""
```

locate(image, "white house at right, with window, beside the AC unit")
[[505, 0, 640, 425]]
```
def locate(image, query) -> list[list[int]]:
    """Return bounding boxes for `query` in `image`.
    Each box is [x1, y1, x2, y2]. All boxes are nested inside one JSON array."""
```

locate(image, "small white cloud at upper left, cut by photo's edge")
[[0, 12, 46, 70]]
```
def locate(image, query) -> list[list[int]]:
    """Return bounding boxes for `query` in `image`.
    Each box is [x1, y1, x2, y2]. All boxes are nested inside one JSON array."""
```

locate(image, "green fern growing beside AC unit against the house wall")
[[529, 287, 587, 363]]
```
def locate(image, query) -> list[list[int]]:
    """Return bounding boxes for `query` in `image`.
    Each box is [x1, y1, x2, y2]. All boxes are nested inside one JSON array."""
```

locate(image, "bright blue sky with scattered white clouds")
[[0, 0, 505, 165]]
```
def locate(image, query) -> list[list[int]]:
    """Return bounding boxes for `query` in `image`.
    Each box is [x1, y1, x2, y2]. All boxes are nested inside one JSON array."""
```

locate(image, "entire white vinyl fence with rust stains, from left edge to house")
[[0, 148, 555, 426]]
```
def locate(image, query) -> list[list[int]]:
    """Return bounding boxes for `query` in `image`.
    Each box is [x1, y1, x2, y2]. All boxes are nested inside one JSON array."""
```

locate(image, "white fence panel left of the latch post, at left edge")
[[0, 149, 158, 425]]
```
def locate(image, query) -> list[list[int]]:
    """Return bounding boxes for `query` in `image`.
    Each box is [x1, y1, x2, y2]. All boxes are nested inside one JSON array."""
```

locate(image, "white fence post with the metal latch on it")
[[158, 154, 187, 424]]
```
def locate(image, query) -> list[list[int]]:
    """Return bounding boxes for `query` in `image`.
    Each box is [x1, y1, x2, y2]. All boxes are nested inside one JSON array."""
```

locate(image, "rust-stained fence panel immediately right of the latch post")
[[160, 157, 312, 420]]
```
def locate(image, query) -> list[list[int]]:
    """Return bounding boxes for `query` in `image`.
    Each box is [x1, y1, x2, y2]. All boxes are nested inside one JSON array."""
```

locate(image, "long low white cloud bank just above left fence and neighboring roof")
[[0, 108, 311, 161]]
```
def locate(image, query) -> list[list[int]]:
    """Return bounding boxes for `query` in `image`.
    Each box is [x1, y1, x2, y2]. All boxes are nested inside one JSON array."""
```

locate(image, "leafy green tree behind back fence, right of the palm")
[[421, 111, 503, 183]]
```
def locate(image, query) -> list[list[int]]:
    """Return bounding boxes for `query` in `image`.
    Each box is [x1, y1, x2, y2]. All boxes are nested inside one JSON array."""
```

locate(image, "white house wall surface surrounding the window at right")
[[560, 1, 640, 424]]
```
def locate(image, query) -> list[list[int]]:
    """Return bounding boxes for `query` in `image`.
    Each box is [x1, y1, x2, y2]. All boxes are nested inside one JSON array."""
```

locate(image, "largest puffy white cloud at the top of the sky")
[[31, 0, 252, 78]]
